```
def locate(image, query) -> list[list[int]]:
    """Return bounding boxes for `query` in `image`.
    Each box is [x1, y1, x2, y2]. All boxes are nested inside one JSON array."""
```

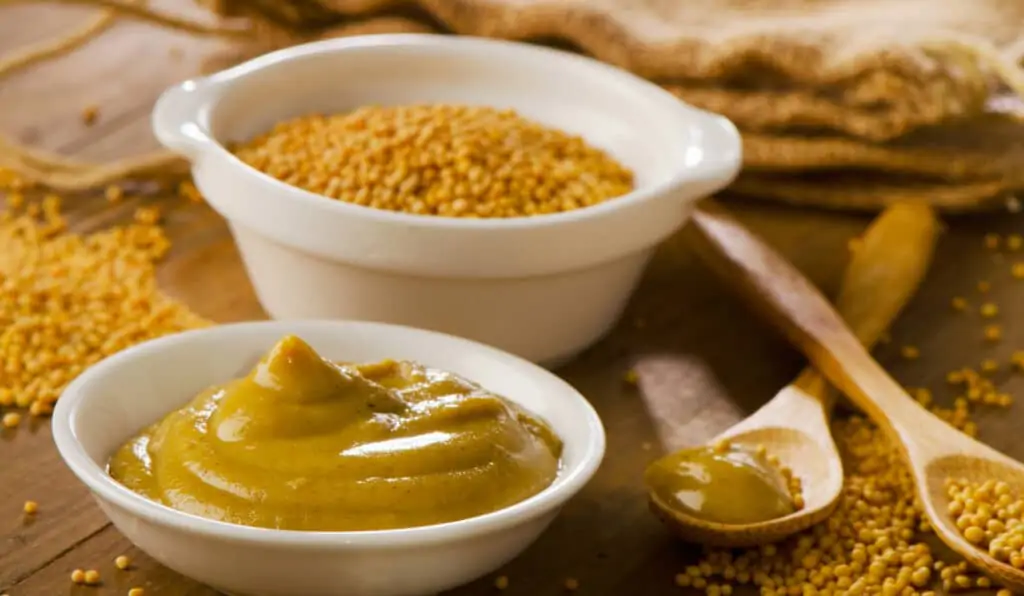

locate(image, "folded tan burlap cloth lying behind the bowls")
[[6, 0, 1024, 210]]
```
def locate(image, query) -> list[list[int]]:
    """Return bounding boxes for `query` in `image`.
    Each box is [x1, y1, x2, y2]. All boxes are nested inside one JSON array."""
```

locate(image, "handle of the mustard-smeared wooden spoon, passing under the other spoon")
[[795, 203, 940, 397]]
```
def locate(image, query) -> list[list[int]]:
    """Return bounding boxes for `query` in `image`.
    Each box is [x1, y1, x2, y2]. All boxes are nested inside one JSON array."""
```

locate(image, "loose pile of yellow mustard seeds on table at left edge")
[[0, 182, 207, 427]]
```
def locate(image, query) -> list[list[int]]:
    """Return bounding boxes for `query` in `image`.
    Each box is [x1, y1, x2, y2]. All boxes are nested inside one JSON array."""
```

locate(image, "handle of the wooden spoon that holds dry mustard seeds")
[[693, 202, 966, 451]]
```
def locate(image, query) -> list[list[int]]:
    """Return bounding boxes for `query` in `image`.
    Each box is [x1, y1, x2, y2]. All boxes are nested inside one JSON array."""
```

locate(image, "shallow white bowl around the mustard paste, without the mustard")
[[53, 321, 604, 596]]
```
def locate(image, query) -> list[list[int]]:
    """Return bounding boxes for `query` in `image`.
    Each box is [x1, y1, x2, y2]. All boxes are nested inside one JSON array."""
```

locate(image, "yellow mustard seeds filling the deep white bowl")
[[234, 104, 633, 217]]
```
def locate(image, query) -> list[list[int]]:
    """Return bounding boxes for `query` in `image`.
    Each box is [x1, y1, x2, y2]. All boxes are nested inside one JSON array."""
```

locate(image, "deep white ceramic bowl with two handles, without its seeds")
[[153, 35, 740, 364]]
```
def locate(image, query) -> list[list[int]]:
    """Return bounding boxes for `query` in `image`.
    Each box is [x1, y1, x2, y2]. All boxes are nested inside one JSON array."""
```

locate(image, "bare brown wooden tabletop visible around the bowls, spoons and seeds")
[[0, 5, 1024, 596]]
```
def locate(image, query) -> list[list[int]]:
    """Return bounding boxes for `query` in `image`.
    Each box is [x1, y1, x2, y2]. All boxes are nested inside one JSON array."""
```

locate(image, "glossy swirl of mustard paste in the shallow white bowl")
[[109, 336, 562, 531]]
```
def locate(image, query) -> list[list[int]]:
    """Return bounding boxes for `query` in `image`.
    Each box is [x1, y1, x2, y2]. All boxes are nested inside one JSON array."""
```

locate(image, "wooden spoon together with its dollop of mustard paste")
[[644, 205, 939, 547]]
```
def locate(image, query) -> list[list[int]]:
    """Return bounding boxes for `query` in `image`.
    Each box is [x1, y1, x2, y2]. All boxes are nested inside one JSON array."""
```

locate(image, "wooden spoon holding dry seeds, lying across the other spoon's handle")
[[693, 204, 1024, 591]]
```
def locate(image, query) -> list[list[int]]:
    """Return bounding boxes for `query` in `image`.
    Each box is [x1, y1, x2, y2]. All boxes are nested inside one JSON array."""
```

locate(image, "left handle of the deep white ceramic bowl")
[[153, 79, 216, 161]]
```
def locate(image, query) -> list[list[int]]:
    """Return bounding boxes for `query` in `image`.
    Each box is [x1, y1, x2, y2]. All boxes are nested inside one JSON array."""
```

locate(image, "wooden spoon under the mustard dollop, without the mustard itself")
[[649, 205, 938, 547]]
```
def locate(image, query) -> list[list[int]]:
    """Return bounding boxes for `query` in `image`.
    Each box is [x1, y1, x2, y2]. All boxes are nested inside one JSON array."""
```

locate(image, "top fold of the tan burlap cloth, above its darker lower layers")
[[199, 0, 1024, 140]]
